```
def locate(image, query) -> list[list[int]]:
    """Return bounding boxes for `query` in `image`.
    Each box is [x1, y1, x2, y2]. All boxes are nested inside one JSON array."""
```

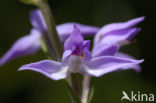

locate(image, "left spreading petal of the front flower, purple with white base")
[[19, 60, 68, 80]]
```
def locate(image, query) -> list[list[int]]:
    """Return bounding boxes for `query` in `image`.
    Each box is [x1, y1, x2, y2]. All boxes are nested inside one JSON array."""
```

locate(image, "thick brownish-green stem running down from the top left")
[[38, 0, 63, 61]]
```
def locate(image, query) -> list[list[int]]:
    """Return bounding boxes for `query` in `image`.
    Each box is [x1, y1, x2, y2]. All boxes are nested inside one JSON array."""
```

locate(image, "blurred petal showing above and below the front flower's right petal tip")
[[115, 52, 141, 72]]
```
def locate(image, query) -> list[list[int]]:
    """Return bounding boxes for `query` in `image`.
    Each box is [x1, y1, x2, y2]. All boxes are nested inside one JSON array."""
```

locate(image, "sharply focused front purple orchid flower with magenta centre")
[[19, 25, 143, 80]]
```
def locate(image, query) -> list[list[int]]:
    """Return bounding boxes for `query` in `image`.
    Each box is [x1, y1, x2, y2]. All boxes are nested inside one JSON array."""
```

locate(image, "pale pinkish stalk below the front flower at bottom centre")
[[81, 76, 90, 103]]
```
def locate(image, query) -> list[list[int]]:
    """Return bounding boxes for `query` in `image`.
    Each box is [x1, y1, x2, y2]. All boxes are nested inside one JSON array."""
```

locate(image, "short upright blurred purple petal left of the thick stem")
[[30, 9, 47, 32]]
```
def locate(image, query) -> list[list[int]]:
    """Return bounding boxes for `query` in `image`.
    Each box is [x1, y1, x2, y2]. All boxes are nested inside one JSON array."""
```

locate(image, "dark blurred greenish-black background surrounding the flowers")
[[0, 0, 156, 103]]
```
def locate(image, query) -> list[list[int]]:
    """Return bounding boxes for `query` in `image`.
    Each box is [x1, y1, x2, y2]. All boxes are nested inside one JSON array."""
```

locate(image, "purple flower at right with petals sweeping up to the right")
[[94, 17, 145, 45]]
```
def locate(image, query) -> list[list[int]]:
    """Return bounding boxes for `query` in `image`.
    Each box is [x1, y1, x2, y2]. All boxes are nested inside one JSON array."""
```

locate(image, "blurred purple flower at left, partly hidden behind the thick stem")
[[0, 10, 99, 66]]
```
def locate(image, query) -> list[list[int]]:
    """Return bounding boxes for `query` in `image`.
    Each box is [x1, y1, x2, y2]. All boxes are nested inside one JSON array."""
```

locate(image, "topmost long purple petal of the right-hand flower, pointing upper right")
[[94, 16, 145, 45]]
